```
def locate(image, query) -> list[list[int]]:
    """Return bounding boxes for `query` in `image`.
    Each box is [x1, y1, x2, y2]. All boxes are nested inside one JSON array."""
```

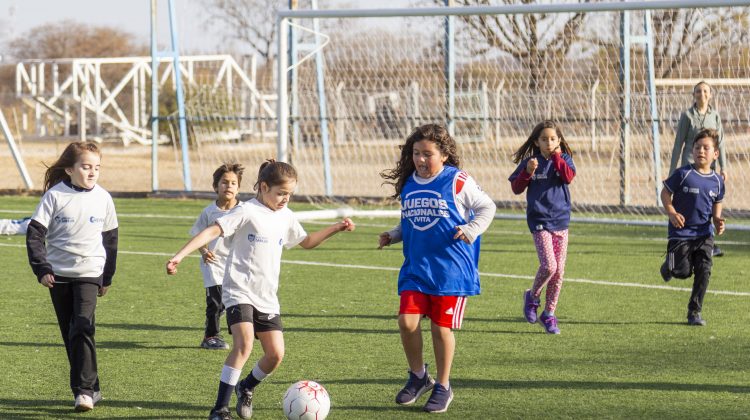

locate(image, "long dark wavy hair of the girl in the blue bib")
[[380, 124, 460, 198]]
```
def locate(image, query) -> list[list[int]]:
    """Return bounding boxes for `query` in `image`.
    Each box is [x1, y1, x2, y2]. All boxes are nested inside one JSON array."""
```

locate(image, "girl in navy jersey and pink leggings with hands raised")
[[508, 121, 576, 334]]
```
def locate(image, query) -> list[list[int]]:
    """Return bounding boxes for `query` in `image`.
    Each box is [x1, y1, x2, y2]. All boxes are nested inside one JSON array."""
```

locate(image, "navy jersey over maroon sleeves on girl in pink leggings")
[[508, 153, 576, 233]]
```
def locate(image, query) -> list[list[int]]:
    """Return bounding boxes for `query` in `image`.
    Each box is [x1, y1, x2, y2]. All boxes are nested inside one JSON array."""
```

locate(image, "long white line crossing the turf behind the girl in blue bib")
[[0, 244, 750, 296]]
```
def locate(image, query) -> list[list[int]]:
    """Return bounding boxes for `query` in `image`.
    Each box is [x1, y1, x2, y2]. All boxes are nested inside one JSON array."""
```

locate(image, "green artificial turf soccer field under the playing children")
[[0, 197, 750, 419]]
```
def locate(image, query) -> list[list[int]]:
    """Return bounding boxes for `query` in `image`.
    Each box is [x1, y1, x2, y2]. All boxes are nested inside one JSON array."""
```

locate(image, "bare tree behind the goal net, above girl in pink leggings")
[[434, 0, 585, 92]]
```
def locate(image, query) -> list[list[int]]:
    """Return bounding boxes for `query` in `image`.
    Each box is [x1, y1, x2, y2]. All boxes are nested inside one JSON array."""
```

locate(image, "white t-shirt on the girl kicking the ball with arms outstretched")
[[216, 198, 307, 314]]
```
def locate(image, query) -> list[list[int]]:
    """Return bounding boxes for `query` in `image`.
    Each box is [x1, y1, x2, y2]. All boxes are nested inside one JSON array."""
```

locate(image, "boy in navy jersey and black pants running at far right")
[[661, 129, 724, 325]]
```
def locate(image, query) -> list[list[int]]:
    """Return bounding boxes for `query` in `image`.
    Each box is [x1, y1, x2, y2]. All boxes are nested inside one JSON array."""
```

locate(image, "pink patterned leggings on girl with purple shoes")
[[531, 229, 568, 313]]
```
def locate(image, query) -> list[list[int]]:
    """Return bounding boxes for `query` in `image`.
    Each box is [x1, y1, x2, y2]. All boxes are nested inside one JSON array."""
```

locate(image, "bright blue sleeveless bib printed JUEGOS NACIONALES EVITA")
[[398, 166, 480, 296]]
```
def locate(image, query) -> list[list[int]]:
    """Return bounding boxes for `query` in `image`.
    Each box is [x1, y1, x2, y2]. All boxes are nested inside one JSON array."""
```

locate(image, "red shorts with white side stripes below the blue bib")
[[398, 290, 466, 329]]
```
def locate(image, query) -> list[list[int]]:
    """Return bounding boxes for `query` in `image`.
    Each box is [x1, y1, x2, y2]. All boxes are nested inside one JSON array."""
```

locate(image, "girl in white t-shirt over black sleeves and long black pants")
[[26, 142, 118, 411]]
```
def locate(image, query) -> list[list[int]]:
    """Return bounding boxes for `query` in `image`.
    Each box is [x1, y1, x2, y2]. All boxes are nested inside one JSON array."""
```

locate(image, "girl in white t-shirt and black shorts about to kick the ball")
[[167, 160, 354, 419]]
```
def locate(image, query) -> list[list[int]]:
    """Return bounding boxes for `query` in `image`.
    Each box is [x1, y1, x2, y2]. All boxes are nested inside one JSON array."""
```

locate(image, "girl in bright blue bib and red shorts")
[[379, 124, 495, 413]]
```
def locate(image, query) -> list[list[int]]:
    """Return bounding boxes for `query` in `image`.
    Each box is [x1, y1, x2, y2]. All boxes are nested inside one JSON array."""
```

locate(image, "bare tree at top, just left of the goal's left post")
[[205, 0, 288, 62]]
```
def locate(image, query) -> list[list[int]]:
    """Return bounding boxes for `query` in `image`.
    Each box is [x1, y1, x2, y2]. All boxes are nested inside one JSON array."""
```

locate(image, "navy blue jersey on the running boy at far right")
[[664, 165, 724, 239]]
